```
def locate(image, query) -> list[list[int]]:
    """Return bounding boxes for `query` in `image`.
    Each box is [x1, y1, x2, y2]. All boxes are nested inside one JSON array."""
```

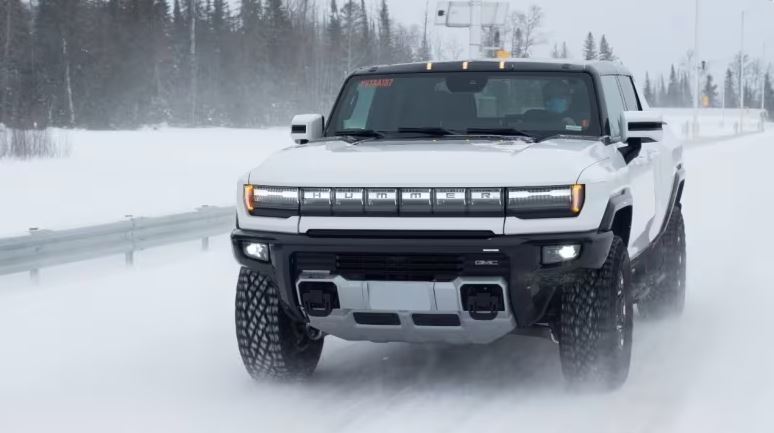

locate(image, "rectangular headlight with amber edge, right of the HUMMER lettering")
[[508, 185, 585, 219]]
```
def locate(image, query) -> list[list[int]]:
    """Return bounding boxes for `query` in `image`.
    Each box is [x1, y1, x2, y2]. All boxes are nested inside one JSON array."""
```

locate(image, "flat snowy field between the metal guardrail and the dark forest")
[[0, 128, 293, 236]]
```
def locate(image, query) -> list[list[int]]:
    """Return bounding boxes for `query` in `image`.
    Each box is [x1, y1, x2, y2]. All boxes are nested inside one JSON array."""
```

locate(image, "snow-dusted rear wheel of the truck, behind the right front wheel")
[[637, 206, 686, 319]]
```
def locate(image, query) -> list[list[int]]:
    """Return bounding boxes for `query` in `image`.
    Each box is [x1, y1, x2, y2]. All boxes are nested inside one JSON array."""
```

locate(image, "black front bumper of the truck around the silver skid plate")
[[231, 229, 613, 336]]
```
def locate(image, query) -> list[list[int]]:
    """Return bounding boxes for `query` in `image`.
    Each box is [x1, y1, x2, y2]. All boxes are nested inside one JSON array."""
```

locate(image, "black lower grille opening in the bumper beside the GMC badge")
[[294, 253, 509, 281]]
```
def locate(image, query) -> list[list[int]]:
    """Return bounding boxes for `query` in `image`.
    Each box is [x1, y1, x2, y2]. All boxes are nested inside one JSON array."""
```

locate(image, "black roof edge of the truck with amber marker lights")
[[352, 59, 632, 76]]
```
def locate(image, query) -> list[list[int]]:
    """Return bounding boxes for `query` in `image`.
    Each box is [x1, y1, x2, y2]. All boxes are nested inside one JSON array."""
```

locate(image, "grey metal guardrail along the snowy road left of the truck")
[[0, 206, 236, 280]]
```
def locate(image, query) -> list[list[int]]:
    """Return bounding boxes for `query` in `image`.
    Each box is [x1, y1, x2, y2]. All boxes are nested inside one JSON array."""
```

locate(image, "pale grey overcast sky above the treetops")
[[231, 0, 774, 78]]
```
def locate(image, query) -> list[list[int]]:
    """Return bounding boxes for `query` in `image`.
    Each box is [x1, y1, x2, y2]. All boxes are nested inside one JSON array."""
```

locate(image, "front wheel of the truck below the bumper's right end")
[[559, 236, 633, 390]]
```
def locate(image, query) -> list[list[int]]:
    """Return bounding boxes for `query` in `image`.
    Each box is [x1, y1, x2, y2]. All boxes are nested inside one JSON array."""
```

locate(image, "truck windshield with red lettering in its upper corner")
[[326, 72, 601, 138]]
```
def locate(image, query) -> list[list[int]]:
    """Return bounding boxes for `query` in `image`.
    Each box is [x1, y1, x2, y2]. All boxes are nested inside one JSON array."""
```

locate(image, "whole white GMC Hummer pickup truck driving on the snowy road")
[[232, 60, 686, 389]]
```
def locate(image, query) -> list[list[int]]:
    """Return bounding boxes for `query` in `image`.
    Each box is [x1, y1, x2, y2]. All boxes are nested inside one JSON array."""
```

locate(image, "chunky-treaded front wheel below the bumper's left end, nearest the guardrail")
[[236, 267, 323, 379]]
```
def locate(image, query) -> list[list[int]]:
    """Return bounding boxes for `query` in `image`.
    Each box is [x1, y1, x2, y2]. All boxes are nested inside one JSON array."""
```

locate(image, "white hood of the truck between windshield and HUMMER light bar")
[[250, 139, 605, 188]]
